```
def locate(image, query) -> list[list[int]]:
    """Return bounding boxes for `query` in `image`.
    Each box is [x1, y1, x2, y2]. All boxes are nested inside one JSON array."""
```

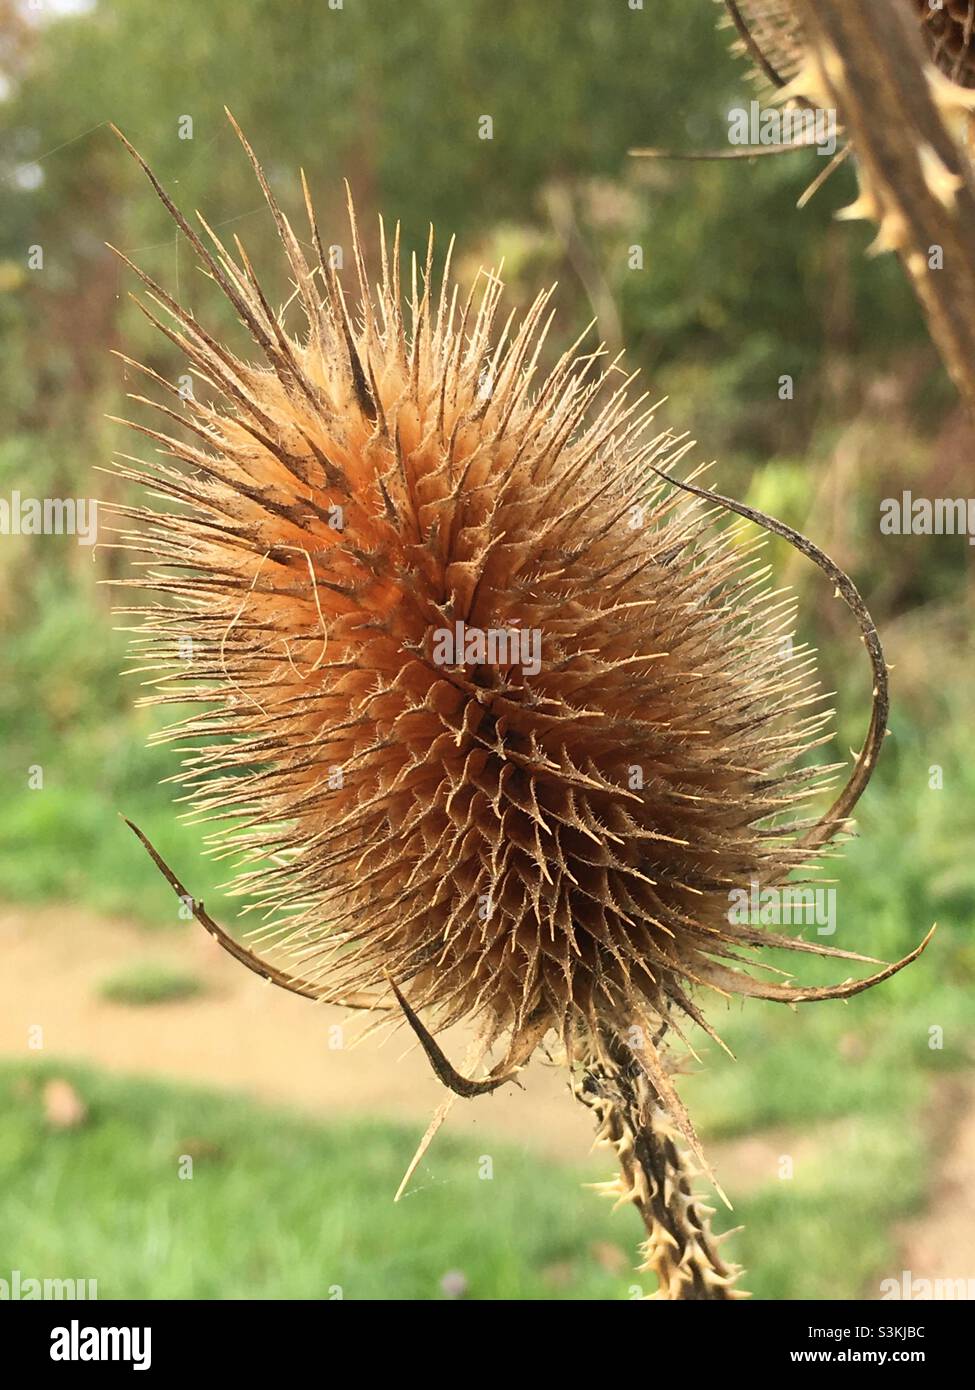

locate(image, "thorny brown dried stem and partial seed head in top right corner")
[[726, 0, 975, 409]]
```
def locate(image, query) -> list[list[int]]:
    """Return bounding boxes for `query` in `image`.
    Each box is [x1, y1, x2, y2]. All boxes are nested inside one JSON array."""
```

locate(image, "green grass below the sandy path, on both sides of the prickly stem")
[[0, 1063, 924, 1301]]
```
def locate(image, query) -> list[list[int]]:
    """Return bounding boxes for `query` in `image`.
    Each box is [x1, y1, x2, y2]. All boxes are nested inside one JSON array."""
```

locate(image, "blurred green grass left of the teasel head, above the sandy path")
[[0, 574, 229, 926]]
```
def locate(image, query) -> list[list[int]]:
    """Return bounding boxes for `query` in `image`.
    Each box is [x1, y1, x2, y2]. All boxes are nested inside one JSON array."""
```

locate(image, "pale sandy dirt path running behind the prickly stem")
[[0, 908, 975, 1295]]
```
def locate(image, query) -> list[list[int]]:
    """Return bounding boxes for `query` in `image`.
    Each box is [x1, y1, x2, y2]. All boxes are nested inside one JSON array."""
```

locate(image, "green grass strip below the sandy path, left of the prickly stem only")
[[0, 1066, 638, 1300]]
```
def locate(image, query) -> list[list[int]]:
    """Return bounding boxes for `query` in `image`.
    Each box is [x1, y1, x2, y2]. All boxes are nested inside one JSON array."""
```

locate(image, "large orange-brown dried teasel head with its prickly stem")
[[106, 119, 924, 1298]]
